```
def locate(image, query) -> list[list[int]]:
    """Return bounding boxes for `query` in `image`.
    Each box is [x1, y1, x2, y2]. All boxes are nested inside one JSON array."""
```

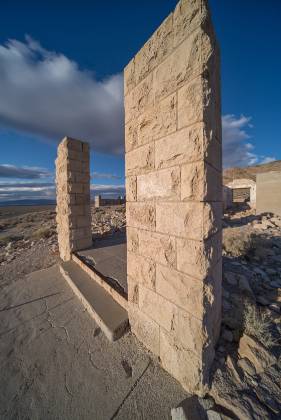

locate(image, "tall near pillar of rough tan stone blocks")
[[124, 0, 222, 394]]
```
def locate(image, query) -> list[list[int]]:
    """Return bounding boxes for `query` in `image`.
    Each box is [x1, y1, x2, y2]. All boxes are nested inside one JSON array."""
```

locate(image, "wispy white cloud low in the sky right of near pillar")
[[222, 114, 275, 167]]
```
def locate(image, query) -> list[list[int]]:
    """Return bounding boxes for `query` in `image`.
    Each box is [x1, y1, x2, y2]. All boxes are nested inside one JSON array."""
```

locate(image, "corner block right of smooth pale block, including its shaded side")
[[181, 161, 222, 201]]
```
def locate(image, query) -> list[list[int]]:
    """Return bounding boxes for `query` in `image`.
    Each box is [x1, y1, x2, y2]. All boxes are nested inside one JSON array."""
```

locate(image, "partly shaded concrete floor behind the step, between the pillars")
[[77, 233, 128, 294]]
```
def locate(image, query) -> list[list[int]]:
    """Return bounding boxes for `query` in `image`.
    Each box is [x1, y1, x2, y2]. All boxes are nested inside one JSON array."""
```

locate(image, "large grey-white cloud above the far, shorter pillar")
[[0, 36, 124, 153]]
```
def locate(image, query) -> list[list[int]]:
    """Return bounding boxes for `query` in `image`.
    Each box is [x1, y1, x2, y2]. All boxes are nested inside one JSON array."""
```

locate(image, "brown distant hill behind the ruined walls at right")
[[223, 160, 281, 184]]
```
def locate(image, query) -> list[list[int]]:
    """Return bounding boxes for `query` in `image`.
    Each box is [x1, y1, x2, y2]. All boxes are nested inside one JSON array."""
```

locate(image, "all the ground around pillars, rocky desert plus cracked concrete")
[[0, 206, 281, 420]]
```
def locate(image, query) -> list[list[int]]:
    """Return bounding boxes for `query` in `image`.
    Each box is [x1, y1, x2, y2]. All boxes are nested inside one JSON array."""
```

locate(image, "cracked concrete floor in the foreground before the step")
[[0, 265, 186, 420]]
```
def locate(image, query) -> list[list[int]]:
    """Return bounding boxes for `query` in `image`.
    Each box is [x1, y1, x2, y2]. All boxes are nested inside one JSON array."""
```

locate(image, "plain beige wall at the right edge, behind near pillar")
[[257, 172, 281, 216]]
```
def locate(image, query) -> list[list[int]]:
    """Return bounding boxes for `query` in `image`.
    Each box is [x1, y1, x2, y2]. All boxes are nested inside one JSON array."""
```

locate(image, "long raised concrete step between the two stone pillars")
[[60, 261, 129, 341]]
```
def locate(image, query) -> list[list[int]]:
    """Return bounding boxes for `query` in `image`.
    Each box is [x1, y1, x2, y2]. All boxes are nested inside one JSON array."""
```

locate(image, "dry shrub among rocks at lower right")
[[243, 302, 277, 348]]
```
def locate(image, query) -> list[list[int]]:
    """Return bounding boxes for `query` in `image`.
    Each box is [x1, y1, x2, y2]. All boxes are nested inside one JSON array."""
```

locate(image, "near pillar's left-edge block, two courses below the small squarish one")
[[127, 252, 156, 289]]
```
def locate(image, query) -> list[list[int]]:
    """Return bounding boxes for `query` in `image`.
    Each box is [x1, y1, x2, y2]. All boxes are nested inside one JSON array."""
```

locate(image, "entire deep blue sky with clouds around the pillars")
[[0, 0, 281, 201]]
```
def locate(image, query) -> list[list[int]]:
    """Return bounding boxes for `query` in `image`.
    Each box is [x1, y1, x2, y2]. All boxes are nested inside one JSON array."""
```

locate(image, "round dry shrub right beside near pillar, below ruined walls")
[[222, 228, 253, 257]]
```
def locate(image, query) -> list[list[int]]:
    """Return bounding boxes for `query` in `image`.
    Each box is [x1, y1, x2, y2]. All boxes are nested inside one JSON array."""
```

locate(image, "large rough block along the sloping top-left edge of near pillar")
[[134, 13, 173, 84]]
